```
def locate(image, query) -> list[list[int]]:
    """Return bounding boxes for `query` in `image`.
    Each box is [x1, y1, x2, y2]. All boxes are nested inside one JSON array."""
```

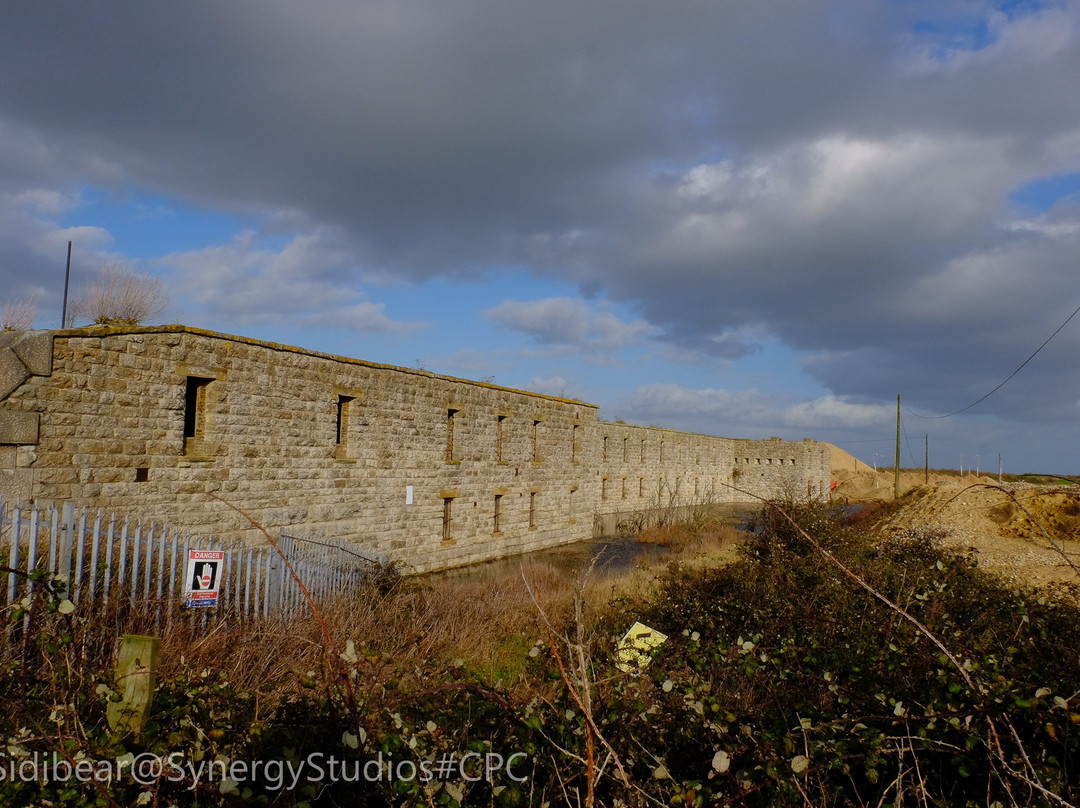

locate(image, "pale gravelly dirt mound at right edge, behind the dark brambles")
[[879, 477, 1080, 596]]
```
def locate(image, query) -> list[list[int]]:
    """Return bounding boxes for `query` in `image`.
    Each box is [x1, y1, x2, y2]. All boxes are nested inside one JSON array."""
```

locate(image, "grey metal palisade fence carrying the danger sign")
[[0, 499, 380, 620]]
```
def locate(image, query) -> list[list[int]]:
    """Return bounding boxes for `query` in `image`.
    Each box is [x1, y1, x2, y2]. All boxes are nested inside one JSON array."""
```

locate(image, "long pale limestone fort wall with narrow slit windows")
[[0, 325, 829, 571]]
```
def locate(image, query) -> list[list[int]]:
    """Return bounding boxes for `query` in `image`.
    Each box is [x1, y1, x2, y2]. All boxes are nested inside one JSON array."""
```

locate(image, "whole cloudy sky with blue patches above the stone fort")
[[0, 0, 1080, 473]]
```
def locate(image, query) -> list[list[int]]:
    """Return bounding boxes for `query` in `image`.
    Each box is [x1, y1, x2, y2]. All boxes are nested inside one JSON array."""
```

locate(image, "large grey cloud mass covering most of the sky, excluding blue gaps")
[[0, 0, 1080, 432]]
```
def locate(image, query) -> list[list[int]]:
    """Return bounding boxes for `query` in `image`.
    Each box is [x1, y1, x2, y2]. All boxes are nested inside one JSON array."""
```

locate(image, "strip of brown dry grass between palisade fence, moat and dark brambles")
[[0, 525, 738, 725]]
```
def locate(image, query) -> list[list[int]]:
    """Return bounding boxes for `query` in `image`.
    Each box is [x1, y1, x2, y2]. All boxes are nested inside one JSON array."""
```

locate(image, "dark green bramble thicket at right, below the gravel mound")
[[622, 504, 1080, 806]]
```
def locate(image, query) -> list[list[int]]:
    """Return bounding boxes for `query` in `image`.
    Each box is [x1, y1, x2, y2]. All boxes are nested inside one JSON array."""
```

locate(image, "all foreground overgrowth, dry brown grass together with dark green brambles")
[[0, 502, 1080, 808]]
